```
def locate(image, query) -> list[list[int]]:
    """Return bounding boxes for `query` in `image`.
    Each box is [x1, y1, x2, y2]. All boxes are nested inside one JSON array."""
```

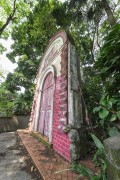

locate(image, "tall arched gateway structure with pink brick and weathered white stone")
[[29, 31, 86, 161]]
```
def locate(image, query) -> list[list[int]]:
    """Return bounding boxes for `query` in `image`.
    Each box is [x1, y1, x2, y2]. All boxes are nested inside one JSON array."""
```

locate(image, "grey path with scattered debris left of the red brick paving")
[[0, 132, 41, 180]]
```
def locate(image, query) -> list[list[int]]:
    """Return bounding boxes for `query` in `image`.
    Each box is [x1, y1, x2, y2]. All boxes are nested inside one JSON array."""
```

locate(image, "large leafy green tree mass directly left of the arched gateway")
[[6, 0, 68, 114]]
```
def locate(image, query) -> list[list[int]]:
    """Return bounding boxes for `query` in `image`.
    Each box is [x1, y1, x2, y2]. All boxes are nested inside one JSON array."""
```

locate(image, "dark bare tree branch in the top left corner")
[[0, 0, 17, 36]]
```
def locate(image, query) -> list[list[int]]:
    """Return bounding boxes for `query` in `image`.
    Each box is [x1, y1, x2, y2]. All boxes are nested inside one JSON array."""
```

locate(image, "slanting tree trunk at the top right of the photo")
[[101, 0, 116, 26]]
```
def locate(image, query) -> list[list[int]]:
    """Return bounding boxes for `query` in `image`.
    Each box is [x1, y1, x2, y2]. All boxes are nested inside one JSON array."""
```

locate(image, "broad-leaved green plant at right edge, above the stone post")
[[93, 94, 120, 136]]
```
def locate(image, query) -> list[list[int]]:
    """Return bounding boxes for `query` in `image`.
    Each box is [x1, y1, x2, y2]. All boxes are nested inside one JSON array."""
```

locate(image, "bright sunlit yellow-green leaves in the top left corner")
[[0, 0, 32, 39]]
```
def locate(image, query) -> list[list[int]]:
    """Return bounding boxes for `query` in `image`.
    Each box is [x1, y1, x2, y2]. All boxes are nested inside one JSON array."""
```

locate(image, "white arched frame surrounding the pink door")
[[34, 65, 55, 143]]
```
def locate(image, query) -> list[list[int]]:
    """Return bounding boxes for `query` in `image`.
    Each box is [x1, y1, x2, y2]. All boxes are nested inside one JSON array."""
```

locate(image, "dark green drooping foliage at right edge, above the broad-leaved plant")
[[95, 24, 120, 95]]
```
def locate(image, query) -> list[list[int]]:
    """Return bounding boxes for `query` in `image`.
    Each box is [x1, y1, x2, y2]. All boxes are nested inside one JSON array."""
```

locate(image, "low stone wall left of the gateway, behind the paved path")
[[0, 116, 30, 133]]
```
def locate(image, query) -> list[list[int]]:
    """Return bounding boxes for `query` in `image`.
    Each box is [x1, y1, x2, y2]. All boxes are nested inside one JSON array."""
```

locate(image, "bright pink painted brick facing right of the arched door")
[[53, 73, 69, 159]]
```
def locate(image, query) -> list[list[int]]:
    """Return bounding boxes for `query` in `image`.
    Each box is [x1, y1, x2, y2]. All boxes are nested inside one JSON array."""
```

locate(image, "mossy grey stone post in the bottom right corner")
[[104, 134, 120, 180]]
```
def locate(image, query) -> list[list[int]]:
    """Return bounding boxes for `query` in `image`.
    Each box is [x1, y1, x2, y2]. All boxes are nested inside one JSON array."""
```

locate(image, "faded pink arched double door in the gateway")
[[38, 73, 53, 137]]
